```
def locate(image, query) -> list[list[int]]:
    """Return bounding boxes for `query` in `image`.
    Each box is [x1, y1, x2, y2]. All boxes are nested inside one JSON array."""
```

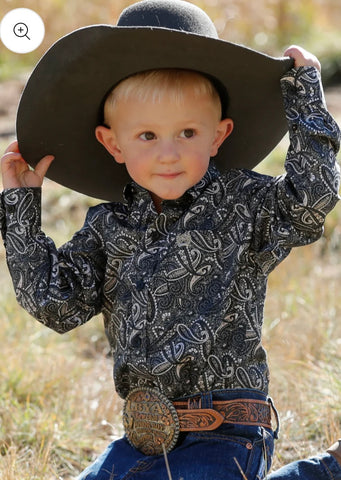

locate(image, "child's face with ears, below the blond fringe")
[[96, 87, 233, 211]]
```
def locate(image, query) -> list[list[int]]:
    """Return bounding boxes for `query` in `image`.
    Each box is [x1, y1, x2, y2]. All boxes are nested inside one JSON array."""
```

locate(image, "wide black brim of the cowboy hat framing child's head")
[[17, 25, 293, 201]]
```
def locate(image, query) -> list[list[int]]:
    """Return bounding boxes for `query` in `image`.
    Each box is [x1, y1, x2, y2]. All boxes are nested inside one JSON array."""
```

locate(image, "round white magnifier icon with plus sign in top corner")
[[0, 8, 45, 53]]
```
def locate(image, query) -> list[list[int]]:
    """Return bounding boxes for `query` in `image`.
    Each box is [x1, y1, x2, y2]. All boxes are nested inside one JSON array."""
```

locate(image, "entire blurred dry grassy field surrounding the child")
[[0, 0, 341, 480]]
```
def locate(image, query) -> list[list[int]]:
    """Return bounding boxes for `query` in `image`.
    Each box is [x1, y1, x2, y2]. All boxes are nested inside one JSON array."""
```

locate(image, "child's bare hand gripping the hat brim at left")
[[1, 141, 54, 189]]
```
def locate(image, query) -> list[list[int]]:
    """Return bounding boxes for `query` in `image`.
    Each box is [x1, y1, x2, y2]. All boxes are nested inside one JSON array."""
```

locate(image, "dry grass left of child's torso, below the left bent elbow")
[[0, 256, 121, 480]]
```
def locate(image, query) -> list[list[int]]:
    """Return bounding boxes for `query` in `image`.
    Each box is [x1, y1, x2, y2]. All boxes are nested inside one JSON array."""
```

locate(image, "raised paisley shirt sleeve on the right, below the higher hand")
[[249, 67, 340, 272]]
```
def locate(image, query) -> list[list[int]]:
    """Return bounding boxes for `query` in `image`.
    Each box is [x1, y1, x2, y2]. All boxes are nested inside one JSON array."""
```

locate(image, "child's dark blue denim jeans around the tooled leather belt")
[[77, 390, 341, 480]]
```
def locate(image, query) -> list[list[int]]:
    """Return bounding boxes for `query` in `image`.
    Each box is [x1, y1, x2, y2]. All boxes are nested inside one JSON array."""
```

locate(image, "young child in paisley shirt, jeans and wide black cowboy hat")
[[0, 0, 341, 480]]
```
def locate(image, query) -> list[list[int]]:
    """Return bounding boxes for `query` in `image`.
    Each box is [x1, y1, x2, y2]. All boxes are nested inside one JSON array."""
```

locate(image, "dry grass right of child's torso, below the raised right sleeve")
[[264, 245, 341, 465]]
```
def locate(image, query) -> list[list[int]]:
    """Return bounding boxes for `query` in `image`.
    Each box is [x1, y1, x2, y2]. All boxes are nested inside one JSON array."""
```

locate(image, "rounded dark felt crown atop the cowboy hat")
[[117, 0, 218, 38]]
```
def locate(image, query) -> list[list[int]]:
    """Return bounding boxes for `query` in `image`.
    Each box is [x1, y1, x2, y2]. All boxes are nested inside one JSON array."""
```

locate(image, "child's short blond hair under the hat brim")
[[104, 69, 221, 123]]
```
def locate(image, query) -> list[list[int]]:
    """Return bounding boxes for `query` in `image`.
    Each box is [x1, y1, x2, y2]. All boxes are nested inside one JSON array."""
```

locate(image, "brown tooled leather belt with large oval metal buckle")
[[123, 388, 277, 455]]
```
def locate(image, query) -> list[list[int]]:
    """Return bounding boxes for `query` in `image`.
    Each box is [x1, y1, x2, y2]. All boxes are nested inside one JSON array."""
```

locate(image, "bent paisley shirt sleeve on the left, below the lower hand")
[[0, 188, 105, 333]]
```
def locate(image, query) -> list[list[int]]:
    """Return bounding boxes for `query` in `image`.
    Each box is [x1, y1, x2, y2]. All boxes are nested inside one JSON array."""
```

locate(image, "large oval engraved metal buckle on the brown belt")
[[123, 388, 180, 455]]
